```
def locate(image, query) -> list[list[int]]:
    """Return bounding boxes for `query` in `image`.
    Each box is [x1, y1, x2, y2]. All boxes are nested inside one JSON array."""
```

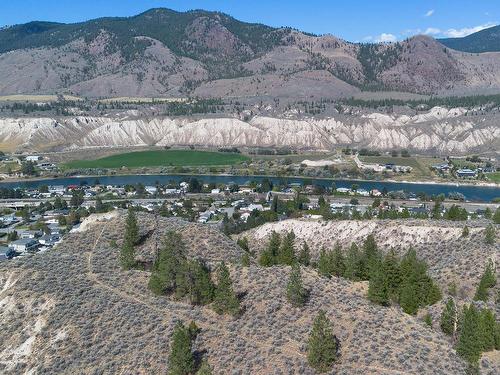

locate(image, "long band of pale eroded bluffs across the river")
[[0, 107, 500, 154]]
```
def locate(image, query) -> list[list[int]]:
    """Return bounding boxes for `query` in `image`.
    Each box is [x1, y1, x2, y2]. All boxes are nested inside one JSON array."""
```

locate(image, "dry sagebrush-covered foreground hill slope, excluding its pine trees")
[[0, 214, 482, 374]]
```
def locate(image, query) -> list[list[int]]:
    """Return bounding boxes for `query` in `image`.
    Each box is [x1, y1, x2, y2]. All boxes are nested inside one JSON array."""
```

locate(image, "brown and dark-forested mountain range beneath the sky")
[[0, 9, 500, 98]]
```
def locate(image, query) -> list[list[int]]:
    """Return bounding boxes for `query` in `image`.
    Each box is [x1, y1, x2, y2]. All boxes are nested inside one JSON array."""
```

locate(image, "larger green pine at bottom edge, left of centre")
[[168, 322, 195, 375]]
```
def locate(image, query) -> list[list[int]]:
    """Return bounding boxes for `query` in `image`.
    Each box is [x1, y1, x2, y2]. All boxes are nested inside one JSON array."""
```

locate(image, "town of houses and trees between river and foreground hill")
[[0, 178, 500, 260]]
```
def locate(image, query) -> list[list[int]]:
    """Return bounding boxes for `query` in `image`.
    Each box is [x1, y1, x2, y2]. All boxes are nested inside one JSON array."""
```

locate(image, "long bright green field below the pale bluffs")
[[64, 150, 250, 169]]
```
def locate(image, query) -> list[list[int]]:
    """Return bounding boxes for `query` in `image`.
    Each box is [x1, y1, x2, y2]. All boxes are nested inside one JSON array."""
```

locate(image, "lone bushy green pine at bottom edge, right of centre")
[[307, 310, 338, 373]]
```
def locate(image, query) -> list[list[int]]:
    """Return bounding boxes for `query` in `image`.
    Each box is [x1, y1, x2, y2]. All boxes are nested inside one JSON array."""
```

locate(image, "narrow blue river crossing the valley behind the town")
[[0, 174, 500, 202]]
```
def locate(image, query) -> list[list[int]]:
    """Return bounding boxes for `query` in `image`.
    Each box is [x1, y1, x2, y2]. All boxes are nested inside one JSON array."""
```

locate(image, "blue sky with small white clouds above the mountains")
[[0, 0, 500, 41]]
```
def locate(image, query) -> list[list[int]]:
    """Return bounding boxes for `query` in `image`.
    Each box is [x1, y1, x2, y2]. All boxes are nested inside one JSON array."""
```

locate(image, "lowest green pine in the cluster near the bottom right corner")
[[456, 304, 482, 364]]
